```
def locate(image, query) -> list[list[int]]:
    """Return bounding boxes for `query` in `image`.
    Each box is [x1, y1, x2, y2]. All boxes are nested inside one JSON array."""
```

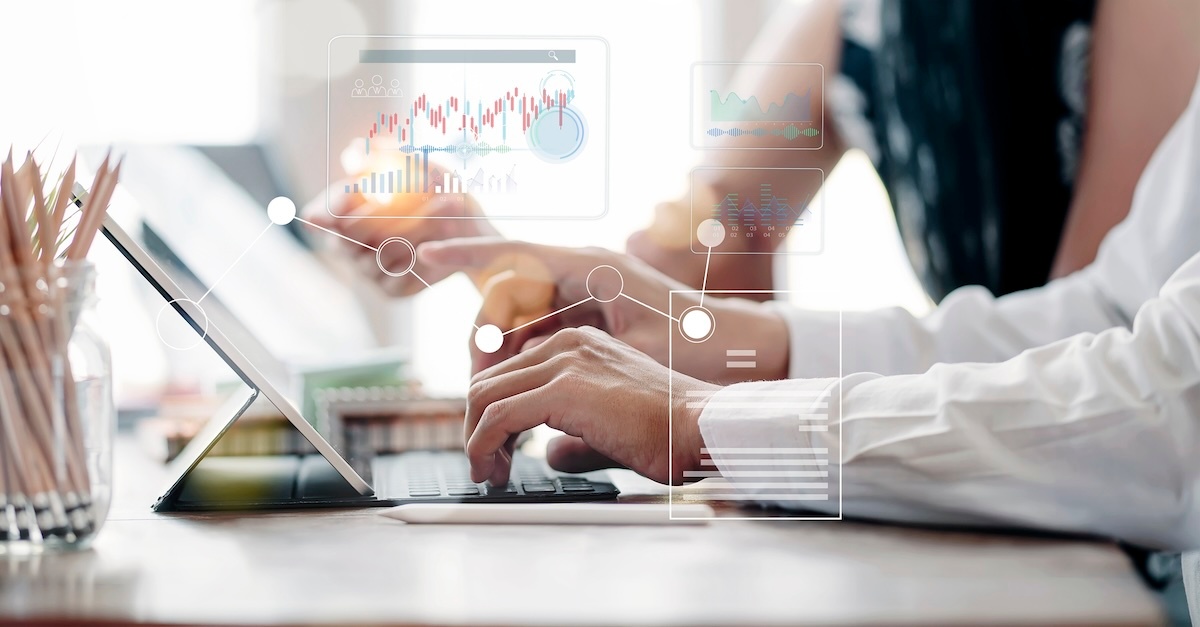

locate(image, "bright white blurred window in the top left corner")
[[0, 0, 260, 145]]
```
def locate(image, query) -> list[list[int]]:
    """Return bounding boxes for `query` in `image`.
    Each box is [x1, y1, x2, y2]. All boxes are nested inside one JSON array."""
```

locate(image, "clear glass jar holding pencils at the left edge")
[[0, 262, 115, 555]]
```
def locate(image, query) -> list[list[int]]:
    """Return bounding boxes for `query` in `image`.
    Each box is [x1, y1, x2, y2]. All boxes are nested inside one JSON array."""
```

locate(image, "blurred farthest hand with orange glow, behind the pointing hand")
[[302, 175, 498, 297]]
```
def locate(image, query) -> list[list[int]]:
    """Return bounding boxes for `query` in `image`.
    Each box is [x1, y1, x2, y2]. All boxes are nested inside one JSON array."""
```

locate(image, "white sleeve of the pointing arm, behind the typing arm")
[[769, 71, 1200, 378]]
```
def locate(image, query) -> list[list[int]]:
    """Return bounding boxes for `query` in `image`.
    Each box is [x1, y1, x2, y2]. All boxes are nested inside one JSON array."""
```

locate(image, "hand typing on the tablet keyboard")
[[464, 327, 720, 485]]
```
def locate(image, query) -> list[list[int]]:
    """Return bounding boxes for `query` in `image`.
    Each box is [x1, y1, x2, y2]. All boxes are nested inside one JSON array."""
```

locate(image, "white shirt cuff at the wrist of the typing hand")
[[700, 378, 840, 513]]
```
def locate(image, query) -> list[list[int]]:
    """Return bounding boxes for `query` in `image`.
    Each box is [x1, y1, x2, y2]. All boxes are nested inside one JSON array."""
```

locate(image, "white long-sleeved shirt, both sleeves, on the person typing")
[[700, 65, 1200, 549]]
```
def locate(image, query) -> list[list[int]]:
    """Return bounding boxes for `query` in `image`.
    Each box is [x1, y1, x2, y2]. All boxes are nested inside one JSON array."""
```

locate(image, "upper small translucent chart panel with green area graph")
[[691, 64, 824, 150]]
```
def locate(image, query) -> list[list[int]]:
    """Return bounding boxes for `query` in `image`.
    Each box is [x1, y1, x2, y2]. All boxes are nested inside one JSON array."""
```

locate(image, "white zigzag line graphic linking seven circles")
[[158, 196, 725, 353]]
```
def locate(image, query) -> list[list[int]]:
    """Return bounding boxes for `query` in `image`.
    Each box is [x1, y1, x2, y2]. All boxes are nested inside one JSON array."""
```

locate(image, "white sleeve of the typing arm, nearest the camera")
[[701, 248, 1200, 549]]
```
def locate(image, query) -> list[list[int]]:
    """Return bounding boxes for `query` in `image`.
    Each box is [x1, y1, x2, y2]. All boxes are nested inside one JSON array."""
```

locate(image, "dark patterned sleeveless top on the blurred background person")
[[827, 0, 1094, 300]]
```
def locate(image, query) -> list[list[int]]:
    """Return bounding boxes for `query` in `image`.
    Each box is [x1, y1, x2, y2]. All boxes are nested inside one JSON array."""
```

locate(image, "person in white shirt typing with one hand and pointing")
[[419, 65, 1200, 550]]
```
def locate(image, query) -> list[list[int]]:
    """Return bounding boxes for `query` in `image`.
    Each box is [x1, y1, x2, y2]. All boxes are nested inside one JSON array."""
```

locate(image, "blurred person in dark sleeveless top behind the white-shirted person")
[[629, 0, 1200, 301]]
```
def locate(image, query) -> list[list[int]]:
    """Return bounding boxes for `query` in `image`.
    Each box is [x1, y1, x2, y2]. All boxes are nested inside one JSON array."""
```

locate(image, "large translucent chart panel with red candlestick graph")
[[326, 36, 608, 219]]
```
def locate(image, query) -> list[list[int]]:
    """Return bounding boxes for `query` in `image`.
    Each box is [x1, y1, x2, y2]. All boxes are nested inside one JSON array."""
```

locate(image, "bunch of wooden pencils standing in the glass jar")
[[0, 150, 120, 539]]
